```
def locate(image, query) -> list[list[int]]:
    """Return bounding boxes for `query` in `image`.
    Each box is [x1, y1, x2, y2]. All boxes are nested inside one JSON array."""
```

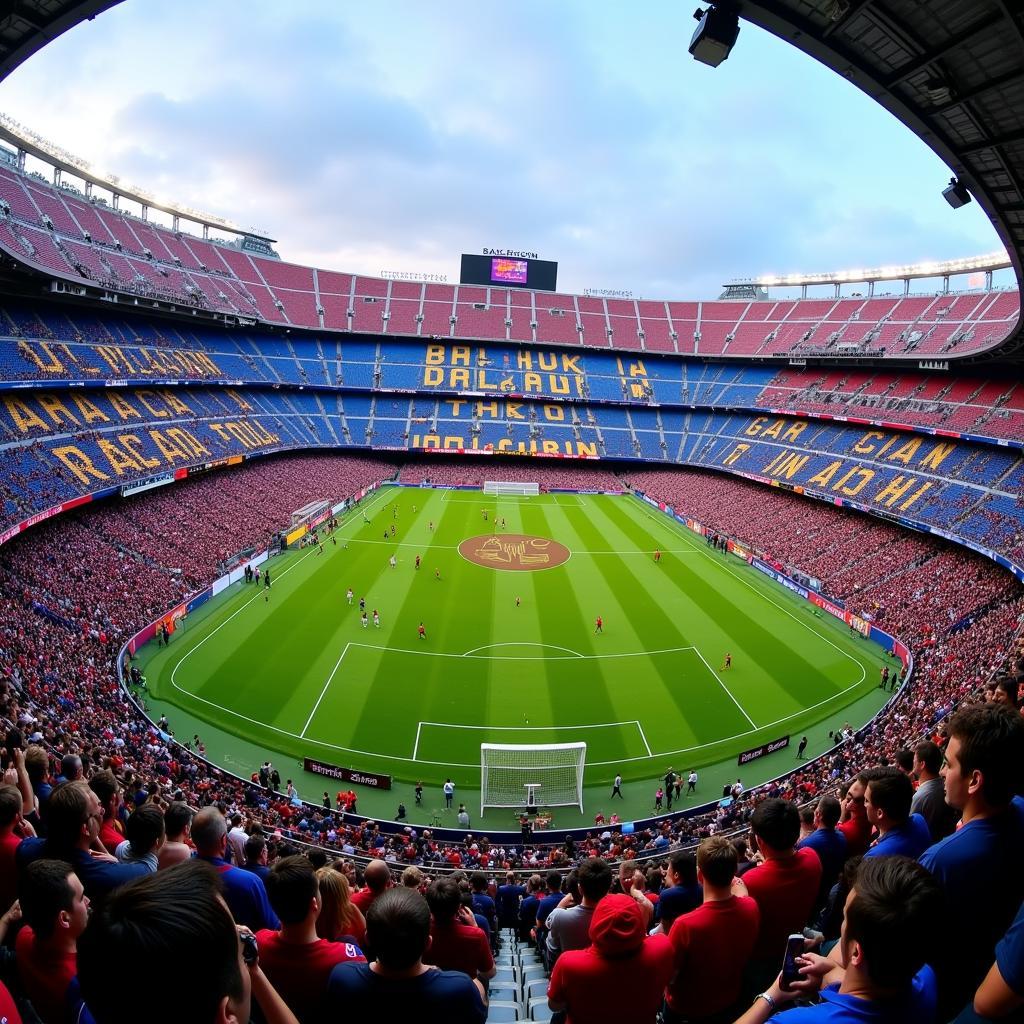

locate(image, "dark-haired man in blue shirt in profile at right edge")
[[921, 703, 1024, 1020]]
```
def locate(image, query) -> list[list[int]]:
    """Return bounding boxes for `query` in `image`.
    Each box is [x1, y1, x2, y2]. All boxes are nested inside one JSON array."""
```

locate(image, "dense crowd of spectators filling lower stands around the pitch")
[[0, 456, 1024, 1024]]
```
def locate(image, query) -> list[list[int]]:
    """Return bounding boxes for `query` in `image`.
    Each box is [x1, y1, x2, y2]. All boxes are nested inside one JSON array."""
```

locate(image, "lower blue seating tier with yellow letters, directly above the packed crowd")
[[0, 378, 1024, 561]]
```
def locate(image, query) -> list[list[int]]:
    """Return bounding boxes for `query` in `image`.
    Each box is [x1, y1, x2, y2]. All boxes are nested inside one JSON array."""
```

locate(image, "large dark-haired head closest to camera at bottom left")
[[78, 860, 251, 1024]]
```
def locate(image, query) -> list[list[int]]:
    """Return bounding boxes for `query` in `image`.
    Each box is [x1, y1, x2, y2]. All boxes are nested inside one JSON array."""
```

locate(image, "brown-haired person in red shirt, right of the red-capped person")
[[664, 836, 761, 1024]]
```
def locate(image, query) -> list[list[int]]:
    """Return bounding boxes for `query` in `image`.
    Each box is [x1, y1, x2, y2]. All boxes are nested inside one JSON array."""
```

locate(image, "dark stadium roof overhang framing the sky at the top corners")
[[0, 0, 1024, 355]]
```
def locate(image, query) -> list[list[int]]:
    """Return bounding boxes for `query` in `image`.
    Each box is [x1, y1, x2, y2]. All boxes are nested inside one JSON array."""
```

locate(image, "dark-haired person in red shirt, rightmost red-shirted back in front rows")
[[733, 799, 821, 992]]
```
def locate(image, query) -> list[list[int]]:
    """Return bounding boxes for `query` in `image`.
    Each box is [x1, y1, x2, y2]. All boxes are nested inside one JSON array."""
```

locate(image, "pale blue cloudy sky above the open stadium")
[[0, 0, 1011, 299]]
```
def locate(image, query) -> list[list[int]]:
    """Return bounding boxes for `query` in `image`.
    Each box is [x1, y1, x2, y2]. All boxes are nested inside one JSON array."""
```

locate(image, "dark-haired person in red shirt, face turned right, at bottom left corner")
[[15, 860, 89, 1024]]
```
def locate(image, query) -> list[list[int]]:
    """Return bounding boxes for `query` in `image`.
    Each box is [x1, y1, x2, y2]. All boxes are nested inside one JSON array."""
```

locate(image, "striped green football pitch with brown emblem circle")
[[141, 486, 892, 827]]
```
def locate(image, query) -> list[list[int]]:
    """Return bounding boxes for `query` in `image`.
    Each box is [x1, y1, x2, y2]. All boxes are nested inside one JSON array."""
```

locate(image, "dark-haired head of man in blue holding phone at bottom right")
[[840, 857, 942, 990]]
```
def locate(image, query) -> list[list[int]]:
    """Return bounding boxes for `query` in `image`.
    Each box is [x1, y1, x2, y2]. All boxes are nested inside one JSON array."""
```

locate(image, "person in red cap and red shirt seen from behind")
[[548, 895, 675, 1024]]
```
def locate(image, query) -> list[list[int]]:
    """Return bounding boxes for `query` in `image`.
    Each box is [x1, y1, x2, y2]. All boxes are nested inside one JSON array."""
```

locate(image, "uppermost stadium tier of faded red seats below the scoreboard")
[[0, 167, 1020, 359]]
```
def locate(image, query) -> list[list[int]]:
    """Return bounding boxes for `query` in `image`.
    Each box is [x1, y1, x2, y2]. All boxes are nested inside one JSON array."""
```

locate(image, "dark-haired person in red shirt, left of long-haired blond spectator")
[[256, 856, 367, 1024]]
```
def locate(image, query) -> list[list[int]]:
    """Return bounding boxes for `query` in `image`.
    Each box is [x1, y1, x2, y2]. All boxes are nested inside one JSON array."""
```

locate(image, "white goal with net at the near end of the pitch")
[[480, 743, 587, 815]]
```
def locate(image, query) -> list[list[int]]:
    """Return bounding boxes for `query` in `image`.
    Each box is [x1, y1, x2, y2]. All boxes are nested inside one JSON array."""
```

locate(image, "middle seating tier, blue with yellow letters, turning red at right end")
[[0, 302, 1024, 442]]
